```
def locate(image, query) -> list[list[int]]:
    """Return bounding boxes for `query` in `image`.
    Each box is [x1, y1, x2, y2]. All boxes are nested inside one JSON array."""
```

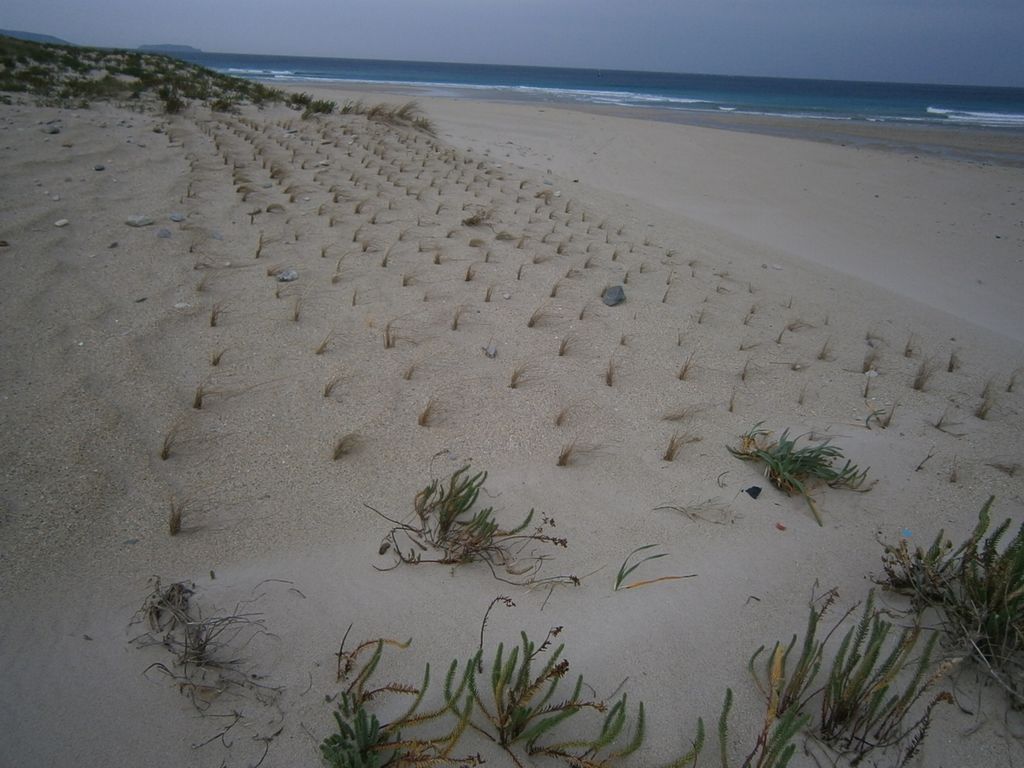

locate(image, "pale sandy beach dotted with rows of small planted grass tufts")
[[0, 83, 1024, 768]]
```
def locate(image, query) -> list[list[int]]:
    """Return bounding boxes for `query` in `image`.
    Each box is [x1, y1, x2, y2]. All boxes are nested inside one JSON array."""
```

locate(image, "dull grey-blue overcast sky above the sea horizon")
[[0, 0, 1024, 87]]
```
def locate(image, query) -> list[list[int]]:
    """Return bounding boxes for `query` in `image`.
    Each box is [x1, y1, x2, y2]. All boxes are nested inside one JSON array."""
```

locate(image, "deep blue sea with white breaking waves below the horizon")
[[177, 52, 1024, 133]]
